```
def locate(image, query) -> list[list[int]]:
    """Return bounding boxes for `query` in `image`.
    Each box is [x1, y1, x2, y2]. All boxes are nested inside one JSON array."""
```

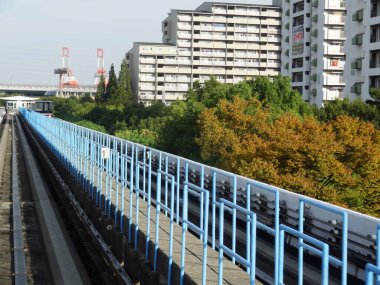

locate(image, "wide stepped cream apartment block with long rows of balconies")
[[127, 2, 281, 103]]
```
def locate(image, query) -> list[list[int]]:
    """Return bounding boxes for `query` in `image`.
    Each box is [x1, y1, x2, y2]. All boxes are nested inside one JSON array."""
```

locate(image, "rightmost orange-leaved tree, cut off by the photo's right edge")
[[329, 116, 380, 213]]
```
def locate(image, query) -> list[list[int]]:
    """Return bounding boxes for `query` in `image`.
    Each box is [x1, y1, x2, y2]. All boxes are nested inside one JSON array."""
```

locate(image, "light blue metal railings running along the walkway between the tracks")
[[20, 109, 380, 285]]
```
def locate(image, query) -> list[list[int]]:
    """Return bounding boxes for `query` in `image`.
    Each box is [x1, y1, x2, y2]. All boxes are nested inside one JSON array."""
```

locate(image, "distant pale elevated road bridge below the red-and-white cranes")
[[0, 84, 96, 98]]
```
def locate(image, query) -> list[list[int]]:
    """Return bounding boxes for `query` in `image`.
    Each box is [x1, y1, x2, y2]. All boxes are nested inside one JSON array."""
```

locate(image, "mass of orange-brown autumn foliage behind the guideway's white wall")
[[196, 97, 380, 216]]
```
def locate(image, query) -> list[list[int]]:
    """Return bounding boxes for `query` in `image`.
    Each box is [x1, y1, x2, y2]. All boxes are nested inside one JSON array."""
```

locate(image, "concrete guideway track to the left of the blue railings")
[[0, 115, 124, 285]]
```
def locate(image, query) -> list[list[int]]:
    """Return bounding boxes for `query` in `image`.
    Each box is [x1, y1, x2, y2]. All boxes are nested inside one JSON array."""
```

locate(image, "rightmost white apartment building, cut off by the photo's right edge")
[[345, 0, 380, 101]]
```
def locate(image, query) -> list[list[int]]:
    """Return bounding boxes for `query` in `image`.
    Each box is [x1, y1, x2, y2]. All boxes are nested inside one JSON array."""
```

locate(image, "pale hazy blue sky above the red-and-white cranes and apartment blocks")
[[0, 0, 271, 85]]
